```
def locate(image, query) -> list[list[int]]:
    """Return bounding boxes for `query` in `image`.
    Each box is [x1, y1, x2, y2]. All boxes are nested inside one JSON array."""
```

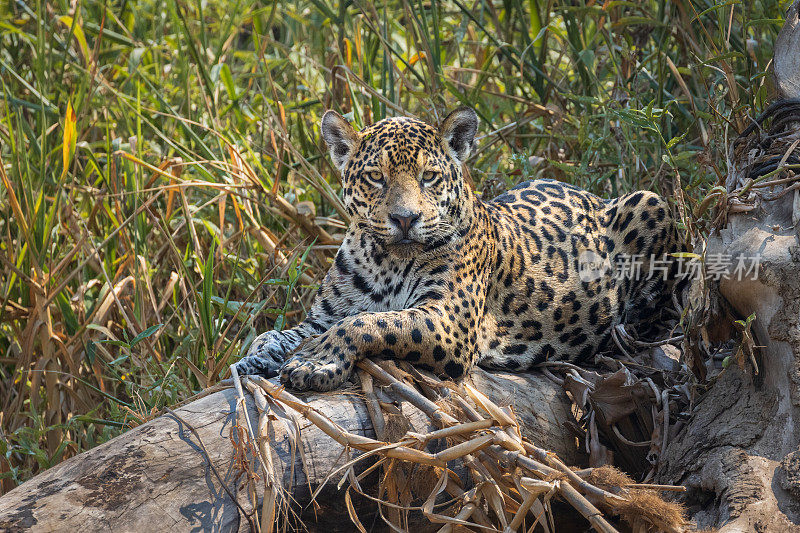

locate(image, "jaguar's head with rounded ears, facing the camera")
[[322, 107, 478, 251]]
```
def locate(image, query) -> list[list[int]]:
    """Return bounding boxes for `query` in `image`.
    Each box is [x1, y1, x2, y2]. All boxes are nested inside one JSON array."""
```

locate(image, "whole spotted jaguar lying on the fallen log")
[[238, 108, 677, 390]]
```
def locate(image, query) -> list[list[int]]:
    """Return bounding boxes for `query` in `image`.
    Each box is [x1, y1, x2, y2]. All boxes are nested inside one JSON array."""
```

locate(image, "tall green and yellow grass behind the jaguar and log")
[[0, 0, 789, 494]]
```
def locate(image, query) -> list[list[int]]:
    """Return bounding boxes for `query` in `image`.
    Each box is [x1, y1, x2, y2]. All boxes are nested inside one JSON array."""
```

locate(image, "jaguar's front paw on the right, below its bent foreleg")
[[280, 342, 353, 392]]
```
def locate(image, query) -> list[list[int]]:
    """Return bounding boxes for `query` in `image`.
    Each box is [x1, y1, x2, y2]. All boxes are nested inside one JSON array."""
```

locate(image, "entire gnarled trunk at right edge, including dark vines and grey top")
[[659, 6, 800, 533]]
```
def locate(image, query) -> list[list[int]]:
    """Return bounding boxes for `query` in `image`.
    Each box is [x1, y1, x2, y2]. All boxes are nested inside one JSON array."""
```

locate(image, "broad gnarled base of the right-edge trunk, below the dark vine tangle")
[[659, 209, 800, 533]]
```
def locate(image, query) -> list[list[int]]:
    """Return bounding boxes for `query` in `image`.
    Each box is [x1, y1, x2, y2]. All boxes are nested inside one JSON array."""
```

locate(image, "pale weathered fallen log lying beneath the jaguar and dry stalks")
[[0, 370, 578, 531]]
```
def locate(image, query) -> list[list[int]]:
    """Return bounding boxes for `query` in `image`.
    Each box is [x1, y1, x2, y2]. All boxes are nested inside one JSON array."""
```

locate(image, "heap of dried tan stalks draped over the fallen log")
[[228, 360, 685, 533]]
